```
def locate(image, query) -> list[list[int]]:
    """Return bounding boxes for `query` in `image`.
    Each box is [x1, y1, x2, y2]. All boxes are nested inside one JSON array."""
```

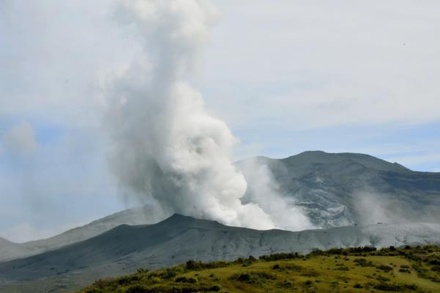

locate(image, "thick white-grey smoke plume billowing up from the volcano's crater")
[[105, 0, 312, 229]]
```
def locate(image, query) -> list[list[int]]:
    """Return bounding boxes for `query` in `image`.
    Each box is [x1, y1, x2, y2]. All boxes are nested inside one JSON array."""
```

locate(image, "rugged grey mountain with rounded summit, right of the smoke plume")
[[237, 151, 440, 227]]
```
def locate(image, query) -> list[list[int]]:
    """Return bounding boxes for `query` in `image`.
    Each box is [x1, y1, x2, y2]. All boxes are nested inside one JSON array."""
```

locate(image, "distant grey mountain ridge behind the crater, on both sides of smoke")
[[0, 151, 440, 261]]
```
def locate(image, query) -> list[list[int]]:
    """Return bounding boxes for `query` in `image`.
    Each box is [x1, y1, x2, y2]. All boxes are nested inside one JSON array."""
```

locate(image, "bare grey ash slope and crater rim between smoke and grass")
[[0, 215, 440, 292]]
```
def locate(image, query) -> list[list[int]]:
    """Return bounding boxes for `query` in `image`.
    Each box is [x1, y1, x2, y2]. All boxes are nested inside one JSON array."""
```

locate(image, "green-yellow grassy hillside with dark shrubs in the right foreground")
[[80, 245, 440, 293]]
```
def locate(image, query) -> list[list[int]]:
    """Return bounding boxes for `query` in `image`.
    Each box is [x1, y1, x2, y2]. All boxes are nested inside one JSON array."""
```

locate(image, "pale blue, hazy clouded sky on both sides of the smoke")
[[0, 0, 440, 241]]
